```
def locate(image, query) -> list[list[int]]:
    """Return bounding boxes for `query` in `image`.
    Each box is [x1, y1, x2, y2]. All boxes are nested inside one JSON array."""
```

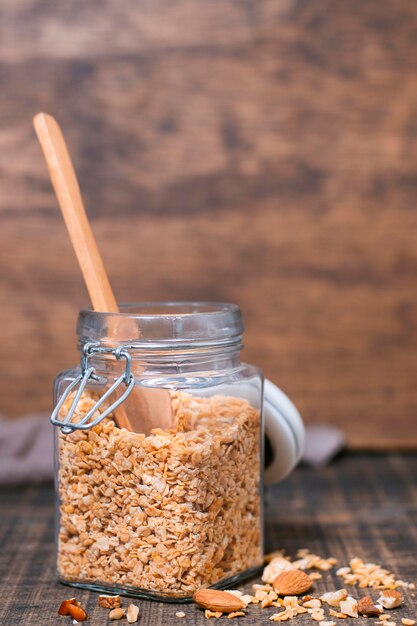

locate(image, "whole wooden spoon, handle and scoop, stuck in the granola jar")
[[33, 113, 173, 434]]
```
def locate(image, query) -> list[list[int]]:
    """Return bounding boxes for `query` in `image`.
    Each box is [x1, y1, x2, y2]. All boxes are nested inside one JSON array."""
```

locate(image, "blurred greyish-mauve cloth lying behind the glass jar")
[[0, 414, 345, 485]]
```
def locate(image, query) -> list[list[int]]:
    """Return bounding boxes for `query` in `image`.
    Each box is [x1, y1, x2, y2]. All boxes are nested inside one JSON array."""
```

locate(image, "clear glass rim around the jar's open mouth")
[[77, 301, 244, 349]]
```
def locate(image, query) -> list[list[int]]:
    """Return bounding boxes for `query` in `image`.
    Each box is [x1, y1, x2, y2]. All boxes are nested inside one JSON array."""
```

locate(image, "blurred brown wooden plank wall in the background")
[[0, 0, 417, 447]]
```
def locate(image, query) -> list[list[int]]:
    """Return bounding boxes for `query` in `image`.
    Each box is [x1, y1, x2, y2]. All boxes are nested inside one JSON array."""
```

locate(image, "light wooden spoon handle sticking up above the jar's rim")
[[33, 113, 118, 313]]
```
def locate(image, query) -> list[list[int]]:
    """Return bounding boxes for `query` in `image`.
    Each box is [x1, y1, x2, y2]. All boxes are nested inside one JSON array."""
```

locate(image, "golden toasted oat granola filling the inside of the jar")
[[57, 391, 263, 598]]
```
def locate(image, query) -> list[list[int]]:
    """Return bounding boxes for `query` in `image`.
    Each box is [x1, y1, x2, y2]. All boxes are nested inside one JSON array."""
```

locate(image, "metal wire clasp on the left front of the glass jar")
[[50, 343, 135, 435]]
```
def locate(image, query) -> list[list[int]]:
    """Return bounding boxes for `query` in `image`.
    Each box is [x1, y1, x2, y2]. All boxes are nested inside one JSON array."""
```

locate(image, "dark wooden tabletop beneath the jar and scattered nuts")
[[0, 454, 417, 626]]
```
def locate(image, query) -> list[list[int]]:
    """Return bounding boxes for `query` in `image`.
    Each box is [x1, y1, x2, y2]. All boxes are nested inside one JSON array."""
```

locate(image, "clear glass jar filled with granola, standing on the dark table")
[[55, 302, 263, 601]]
